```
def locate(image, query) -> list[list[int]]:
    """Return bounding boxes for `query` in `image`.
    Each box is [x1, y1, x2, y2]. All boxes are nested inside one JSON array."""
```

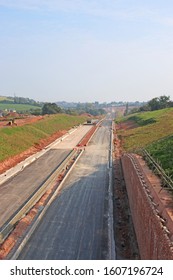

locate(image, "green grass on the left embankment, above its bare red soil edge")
[[0, 114, 86, 162]]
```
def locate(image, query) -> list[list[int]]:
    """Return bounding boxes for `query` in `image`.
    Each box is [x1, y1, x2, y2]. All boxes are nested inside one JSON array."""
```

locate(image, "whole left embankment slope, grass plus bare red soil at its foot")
[[0, 115, 86, 173]]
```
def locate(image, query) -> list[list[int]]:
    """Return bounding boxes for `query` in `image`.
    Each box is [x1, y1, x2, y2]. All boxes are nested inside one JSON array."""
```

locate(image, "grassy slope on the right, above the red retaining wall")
[[116, 108, 173, 175]]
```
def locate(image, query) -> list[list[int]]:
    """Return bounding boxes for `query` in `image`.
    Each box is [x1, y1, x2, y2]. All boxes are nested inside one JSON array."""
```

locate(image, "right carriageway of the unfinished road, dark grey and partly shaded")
[[19, 121, 111, 260]]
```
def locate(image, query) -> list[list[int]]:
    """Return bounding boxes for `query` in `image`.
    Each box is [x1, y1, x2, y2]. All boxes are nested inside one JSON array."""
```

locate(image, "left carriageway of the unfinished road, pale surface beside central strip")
[[0, 126, 91, 227]]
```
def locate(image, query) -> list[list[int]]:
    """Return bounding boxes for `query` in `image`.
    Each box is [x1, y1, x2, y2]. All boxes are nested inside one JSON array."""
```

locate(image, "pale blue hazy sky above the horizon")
[[0, 0, 173, 102]]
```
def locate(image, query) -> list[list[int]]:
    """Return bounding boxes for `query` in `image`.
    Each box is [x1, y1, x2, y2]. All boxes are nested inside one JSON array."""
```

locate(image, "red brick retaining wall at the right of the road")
[[122, 154, 173, 260]]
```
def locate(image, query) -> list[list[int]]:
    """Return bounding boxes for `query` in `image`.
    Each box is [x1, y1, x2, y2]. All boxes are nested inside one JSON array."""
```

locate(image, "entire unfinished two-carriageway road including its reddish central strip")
[[0, 117, 121, 260]]
